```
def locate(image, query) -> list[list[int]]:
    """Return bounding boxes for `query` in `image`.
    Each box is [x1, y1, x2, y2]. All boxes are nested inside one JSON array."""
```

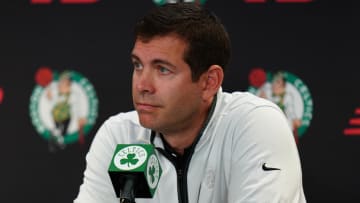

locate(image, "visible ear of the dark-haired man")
[[201, 65, 224, 101]]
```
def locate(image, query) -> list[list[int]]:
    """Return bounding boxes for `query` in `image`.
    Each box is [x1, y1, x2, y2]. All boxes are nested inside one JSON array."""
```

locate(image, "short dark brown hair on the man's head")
[[134, 3, 231, 81]]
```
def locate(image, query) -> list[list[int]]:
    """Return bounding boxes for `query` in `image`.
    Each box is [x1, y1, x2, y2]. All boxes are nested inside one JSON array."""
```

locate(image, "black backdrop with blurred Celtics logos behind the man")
[[0, 0, 360, 203]]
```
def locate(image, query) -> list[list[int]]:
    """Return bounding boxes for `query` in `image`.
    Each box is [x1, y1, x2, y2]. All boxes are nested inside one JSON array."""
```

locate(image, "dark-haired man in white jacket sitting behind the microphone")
[[75, 3, 305, 203]]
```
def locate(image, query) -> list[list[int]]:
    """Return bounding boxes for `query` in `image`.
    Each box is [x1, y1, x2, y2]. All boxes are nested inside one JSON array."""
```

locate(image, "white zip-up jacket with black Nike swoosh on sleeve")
[[74, 89, 306, 203]]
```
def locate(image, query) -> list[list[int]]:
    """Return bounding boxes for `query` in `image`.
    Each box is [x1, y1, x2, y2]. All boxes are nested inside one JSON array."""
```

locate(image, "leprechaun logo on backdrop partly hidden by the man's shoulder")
[[249, 68, 313, 140]]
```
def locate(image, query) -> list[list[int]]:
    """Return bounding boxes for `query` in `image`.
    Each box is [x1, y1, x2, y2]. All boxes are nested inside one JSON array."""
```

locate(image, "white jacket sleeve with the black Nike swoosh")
[[228, 105, 306, 203]]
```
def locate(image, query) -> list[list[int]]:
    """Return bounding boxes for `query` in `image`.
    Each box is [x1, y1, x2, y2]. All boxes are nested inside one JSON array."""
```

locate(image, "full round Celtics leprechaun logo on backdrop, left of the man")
[[30, 67, 98, 151]]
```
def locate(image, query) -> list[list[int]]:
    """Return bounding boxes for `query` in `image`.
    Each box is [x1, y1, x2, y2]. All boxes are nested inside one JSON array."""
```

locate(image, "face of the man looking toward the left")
[[132, 35, 202, 134]]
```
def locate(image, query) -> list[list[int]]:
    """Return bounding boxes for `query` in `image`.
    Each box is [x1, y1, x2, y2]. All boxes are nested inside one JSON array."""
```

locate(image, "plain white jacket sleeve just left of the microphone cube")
[[74, 123, 119, 203]]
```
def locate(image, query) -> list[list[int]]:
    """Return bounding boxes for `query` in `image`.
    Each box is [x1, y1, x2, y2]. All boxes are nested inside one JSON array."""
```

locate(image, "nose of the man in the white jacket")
[[133, 68, 155, 94]]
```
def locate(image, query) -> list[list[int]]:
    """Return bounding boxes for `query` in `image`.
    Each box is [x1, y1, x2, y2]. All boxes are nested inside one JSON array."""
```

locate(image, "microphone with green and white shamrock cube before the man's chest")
[[108, 144, 162, 203]]
